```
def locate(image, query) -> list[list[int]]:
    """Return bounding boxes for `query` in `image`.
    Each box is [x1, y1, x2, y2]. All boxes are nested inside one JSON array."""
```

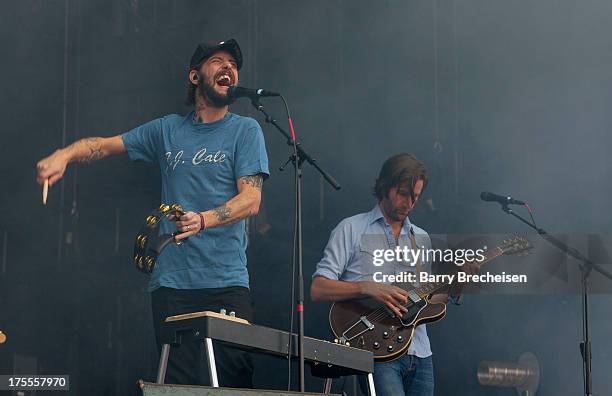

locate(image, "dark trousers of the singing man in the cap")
[[151, 287, 253, 388]]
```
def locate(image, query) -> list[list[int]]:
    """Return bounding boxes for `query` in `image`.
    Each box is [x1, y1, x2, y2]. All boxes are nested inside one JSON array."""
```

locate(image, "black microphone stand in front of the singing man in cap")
[[251, 98, 341, 392]]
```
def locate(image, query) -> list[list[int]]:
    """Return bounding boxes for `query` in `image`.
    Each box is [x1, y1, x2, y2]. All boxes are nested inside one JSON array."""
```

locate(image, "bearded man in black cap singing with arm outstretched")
[[37, 39, 269, 387]]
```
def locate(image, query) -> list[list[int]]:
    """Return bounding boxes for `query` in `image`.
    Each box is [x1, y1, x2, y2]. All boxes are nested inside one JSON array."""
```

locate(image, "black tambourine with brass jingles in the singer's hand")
[[134, 204, 188, 274]]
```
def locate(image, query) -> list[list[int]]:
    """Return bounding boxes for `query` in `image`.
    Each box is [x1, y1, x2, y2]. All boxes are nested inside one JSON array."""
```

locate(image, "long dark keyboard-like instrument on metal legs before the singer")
[[157, 311, 376, 396]]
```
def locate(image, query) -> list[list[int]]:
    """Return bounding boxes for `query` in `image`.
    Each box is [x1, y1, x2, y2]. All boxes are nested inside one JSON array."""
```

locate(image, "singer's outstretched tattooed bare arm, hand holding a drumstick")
[[36, 135, 126, 186]]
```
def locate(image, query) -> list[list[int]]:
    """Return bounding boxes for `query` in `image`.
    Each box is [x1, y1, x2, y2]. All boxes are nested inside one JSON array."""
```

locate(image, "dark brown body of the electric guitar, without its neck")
[[329, 298, 446, 362]]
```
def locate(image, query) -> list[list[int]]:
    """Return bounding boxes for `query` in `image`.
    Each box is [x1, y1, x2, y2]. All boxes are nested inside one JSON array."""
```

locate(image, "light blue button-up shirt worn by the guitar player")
[[313, 205, 431, 358]]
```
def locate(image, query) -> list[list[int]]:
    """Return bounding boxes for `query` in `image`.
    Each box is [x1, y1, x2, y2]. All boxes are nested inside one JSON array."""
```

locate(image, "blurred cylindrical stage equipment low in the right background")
[[477, 352, 540, 396]]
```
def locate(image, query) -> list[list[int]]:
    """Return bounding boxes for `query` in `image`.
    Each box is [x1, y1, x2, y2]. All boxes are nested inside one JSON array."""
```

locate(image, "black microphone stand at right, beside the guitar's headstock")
[[501, 204, 612, 396]]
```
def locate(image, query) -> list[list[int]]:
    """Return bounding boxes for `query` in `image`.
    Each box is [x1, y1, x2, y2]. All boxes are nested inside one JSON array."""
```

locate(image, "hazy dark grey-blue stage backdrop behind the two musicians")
[[0, 0, 612, 395]]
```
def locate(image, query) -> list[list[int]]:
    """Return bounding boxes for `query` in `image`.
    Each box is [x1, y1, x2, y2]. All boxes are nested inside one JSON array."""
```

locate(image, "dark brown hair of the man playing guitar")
[[374, 153, 427, 201]]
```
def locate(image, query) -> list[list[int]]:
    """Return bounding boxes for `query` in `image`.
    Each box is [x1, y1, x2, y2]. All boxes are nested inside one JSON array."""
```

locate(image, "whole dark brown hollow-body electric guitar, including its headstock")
[[329, 237, 531, 362]]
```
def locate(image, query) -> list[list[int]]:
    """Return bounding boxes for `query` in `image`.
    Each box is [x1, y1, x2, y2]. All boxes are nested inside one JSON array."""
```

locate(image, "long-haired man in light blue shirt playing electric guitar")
[[310, 154, 470, 396]]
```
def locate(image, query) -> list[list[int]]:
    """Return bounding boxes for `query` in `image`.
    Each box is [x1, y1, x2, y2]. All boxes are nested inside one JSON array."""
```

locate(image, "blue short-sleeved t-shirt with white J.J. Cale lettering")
[[122, 112, 269, 291]]
